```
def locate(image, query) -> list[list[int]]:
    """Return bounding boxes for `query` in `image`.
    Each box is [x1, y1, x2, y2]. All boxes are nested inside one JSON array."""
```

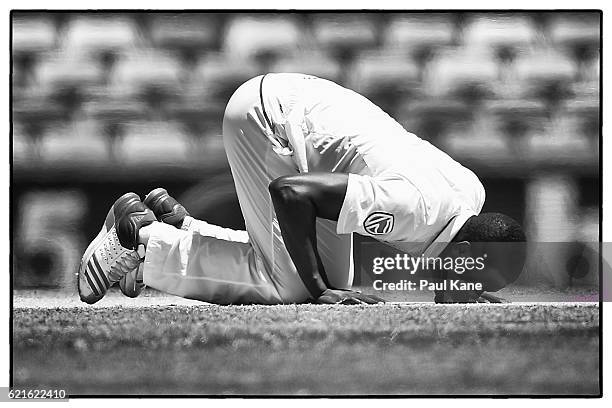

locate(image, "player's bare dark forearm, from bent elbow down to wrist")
[[270, 178, 328, 299]]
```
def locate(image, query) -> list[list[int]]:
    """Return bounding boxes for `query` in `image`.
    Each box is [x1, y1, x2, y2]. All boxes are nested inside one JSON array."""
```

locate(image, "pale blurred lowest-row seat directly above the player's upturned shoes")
[[115, 121, 191, 164]]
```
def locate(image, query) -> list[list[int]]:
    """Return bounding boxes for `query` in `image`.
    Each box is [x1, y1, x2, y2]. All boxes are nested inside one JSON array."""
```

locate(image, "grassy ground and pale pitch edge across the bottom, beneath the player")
[[12, 292, 599, 395]]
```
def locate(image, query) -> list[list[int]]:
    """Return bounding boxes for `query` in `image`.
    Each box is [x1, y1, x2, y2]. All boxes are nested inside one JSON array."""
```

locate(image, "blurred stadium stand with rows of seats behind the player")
[[11, 12, 600, 290]]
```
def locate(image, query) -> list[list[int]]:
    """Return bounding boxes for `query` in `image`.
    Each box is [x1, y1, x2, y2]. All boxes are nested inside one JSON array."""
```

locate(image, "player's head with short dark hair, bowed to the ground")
[[445, 213, 526, 291]]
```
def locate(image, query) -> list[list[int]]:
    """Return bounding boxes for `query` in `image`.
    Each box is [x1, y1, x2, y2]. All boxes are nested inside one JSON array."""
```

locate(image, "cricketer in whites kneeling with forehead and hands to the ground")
[[78, 73, 525, 304]]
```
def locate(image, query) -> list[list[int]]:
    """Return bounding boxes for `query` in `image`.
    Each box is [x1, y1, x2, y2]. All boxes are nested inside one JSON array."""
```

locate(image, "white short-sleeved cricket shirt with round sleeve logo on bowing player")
[[261, 74, 485, 256]]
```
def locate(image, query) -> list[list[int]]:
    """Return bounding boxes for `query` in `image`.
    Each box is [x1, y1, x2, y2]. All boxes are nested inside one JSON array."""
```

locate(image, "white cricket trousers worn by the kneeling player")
[[143, 77, 353, 304]]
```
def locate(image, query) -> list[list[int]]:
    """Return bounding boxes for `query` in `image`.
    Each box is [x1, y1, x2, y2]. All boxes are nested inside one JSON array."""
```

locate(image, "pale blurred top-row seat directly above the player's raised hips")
[[223, 15, 302, 65]]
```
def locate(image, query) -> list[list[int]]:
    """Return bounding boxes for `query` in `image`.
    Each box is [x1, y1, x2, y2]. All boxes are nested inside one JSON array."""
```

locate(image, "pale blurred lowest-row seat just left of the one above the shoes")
[[40, 120, 109, 164]]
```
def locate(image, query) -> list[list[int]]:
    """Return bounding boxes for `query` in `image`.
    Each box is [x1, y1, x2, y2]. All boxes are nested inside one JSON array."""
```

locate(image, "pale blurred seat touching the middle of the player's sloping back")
[[346, 52, 420, 115]]
